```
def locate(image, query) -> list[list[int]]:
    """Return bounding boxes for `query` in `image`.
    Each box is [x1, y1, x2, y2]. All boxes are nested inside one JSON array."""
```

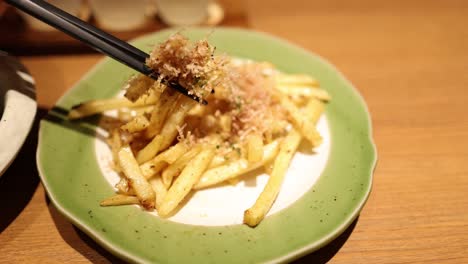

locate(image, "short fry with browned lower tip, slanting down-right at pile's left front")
[[118, 146, 155, 210]]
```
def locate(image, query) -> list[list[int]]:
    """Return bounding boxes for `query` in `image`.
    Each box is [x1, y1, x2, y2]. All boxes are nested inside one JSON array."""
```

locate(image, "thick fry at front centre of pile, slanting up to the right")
[[158, 147, 215, 217]]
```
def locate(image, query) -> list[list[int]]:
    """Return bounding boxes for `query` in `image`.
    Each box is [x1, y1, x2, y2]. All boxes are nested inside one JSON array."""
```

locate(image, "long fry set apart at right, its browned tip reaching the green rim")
[[244, 129, 301, 227]]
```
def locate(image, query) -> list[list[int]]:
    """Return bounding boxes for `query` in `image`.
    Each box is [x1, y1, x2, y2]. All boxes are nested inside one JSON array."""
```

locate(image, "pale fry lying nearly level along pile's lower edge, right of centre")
[[194, 140, 279, 189]]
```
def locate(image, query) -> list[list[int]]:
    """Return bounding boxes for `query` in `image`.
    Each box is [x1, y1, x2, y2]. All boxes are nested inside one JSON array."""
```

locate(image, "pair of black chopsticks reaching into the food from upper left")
[[6, 0, 207, 104]]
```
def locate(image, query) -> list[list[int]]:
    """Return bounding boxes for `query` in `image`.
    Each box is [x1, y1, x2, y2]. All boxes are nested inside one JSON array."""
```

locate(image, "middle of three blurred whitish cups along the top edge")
[[90, 0, 149, 31]]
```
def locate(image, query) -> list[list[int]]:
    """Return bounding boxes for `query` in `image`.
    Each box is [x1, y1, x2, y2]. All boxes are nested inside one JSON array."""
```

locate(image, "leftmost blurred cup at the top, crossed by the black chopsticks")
[[18, 0, 85, 31]]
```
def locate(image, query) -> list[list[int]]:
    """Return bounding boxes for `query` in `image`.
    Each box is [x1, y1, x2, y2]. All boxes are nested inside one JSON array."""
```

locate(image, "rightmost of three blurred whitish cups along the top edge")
[[156, 0, 211, 26]]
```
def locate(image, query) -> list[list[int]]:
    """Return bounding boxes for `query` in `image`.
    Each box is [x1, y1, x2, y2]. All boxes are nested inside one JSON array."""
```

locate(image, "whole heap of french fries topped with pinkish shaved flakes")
[[77, 39, 331, 227]]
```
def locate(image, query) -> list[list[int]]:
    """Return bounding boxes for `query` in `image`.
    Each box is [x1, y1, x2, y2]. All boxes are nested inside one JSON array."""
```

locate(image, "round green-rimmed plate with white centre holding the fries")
[[37, 28, 376, 263]]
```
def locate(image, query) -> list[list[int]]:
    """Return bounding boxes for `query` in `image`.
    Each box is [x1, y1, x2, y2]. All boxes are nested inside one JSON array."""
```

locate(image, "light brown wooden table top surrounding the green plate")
[[0, 0, 468, 263]]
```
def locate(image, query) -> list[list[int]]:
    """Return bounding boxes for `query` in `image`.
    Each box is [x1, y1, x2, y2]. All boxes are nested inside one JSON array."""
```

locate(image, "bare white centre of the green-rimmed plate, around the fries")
[[95, 116, 330, 226]]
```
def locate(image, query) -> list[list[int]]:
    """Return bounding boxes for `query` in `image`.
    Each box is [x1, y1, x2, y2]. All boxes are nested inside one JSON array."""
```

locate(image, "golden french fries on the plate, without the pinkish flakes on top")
[[69, 61, 330, 227]]
